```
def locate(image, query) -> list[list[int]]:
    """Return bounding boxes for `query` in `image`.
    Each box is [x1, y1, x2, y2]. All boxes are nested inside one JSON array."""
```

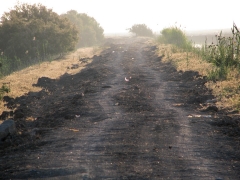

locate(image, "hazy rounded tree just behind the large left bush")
[[62, 10, 104, 47]]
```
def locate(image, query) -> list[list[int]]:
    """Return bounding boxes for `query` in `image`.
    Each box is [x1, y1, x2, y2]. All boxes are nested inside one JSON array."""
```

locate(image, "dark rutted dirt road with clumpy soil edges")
[[0, 38, 240, 180]]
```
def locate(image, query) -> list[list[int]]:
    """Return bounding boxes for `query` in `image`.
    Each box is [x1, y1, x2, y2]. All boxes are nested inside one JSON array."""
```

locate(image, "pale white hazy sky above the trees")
[[0, 0, 240, 33]]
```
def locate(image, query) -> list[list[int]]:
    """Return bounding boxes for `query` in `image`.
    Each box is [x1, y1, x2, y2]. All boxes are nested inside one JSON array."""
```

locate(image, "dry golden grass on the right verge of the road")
[[158, 44, 240, 111]]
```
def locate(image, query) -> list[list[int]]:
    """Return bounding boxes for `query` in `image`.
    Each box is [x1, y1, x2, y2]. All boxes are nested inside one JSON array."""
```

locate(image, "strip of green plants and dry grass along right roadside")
[[156, 24, 240, 112]]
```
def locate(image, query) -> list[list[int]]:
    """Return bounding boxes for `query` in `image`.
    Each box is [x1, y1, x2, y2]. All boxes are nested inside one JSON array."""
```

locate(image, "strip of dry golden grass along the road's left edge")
[[0, 47, 101, 114]]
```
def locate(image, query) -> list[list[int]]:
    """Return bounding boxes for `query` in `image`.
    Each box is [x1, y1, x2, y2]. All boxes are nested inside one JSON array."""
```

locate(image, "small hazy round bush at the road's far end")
[[128, 24, 153, 37]]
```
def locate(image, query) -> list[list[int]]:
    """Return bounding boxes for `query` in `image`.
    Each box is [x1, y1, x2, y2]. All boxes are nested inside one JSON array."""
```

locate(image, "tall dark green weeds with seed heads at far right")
[[201, 24, 240, 80]]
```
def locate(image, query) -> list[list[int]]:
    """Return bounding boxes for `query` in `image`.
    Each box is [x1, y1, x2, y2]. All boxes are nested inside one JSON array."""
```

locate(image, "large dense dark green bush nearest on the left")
[[0, 4, 78, 75]]
